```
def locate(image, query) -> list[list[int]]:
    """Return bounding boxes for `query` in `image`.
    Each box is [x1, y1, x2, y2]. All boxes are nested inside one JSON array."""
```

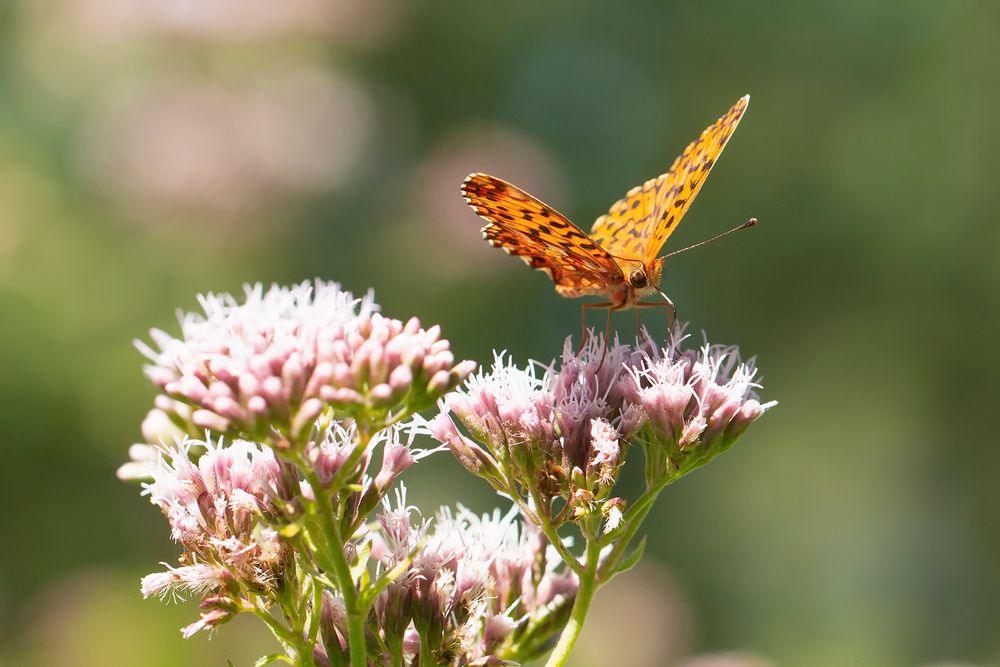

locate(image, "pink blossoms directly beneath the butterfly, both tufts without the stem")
[[429, 328, 771, 516]]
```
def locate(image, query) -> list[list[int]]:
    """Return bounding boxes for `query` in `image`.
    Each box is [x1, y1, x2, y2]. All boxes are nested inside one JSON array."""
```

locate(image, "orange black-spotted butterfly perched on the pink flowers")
[[462, 95, 756, 339]]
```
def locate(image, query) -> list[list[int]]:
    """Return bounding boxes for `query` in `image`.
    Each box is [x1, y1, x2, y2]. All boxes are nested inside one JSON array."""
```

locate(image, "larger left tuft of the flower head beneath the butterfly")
[[428, 337, 646, 516]]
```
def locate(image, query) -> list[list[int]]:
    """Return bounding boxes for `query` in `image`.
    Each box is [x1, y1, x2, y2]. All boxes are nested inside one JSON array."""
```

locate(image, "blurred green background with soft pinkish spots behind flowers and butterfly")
[[0, 0, 1000, 667]]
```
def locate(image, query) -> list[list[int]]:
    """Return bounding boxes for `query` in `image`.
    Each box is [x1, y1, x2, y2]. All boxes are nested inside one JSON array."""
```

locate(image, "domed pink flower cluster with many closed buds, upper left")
[[137, 280, 475, 438]]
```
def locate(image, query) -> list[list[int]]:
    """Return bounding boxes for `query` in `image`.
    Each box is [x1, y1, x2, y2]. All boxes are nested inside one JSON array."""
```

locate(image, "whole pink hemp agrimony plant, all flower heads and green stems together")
[[118, 281, 770, 667]]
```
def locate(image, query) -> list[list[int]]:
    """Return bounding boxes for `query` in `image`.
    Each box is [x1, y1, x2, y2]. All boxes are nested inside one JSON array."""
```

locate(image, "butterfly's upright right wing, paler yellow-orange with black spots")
[[591, 95, 750, 262]]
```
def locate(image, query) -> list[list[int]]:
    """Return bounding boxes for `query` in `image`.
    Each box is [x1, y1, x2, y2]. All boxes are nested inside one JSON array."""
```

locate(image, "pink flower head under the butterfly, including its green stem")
[[428, 327, 772, 665]]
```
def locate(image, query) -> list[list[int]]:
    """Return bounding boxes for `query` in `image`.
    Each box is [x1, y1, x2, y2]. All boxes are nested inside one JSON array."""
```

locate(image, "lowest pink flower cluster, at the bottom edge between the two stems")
[[364, 494, 577, 664]]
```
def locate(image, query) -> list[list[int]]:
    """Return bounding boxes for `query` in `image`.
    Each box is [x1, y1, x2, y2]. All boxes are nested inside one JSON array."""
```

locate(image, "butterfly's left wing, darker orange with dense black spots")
[[462, 174, 624, 296]]
